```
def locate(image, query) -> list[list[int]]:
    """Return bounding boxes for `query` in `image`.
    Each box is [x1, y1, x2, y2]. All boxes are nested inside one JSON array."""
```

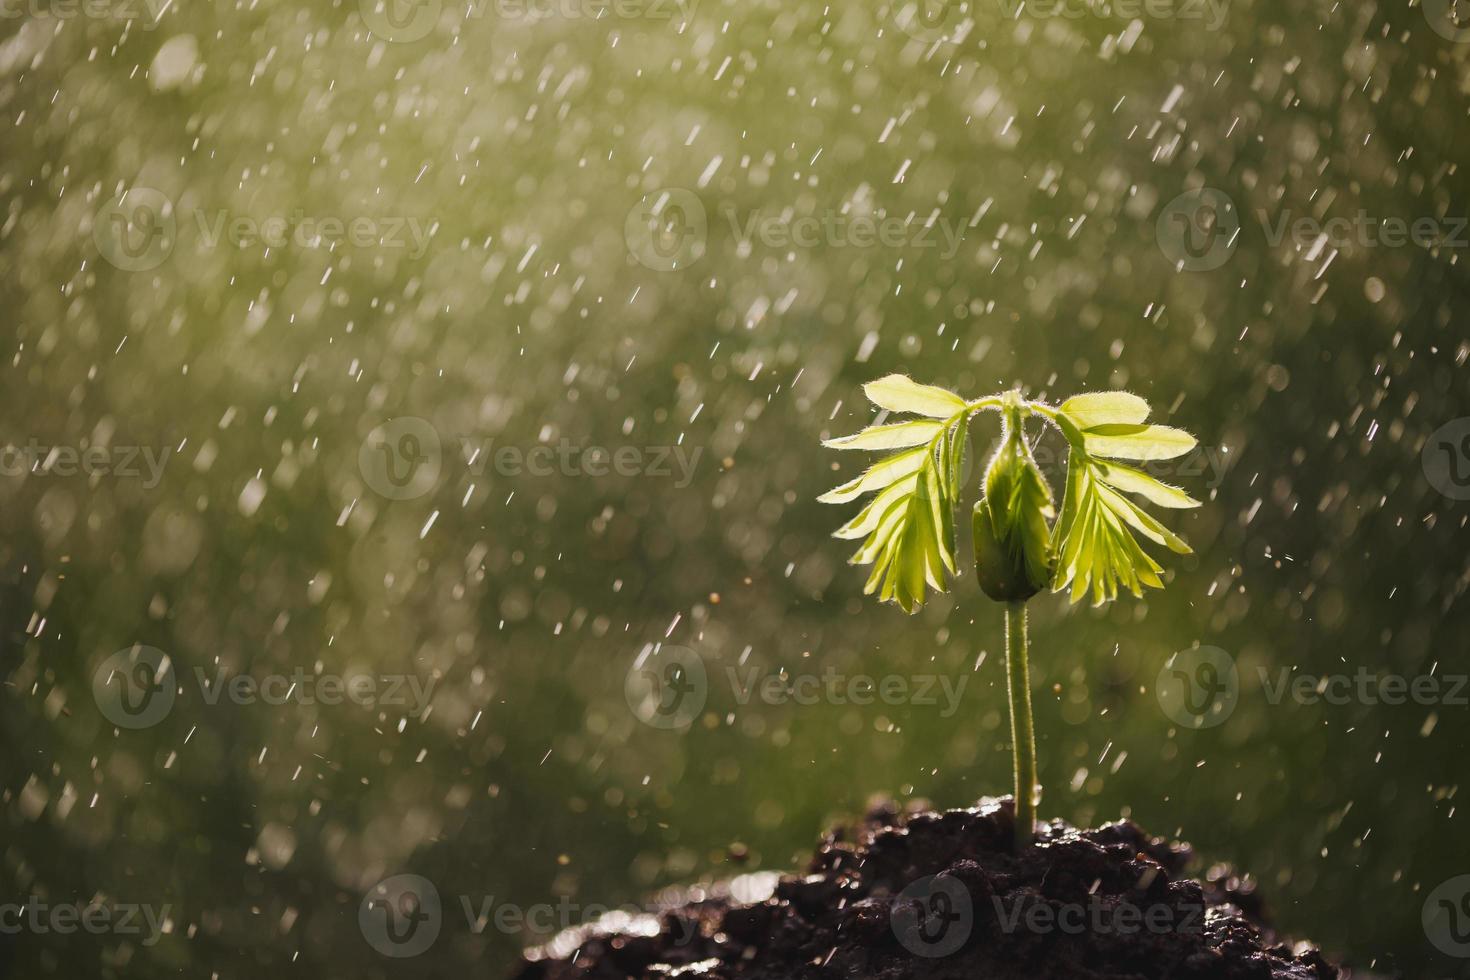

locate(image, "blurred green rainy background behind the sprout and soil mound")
[[0, 0, 1470, 980]]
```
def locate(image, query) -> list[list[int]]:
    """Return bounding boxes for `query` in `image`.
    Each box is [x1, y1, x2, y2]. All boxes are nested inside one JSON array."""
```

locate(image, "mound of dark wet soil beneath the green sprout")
[[516, 798, 1344, 980]]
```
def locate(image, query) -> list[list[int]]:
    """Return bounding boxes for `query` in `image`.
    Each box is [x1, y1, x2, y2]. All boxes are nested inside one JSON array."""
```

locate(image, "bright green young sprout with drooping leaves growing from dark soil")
[[817, 375, 1200, 848]]
